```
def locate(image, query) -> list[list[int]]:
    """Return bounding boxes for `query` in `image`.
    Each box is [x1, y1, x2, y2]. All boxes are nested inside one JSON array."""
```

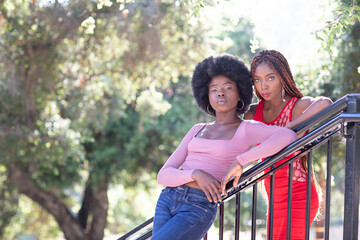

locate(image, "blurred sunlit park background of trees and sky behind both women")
[[0, 0, 360, 240]]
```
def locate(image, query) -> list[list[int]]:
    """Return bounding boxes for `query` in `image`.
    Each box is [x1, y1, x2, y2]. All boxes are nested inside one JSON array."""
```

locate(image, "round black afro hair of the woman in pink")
[[191, 55, 253, 116]]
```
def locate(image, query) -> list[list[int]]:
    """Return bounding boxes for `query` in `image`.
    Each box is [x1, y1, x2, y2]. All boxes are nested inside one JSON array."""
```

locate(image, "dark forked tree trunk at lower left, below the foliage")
[[9, 166, 109, 240]]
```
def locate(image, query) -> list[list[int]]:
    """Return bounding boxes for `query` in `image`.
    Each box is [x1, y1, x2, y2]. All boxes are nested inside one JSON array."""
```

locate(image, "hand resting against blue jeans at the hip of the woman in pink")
[[191, 169, 221, 202]]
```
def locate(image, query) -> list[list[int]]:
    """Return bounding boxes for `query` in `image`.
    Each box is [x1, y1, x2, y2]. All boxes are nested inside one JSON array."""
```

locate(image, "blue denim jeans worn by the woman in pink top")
[[151, 185, 217, 240]]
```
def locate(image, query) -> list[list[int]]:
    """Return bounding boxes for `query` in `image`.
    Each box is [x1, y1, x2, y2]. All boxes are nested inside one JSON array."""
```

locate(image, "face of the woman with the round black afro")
[[209, 75, 240, 113]]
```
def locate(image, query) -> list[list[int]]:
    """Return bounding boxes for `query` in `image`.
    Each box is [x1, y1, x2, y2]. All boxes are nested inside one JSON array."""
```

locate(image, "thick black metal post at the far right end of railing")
[[343, 96, 360, 240]]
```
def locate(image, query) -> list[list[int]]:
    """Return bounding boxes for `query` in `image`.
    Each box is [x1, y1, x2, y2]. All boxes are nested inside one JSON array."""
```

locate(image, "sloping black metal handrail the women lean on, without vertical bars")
[[118, 94, 360, 240]]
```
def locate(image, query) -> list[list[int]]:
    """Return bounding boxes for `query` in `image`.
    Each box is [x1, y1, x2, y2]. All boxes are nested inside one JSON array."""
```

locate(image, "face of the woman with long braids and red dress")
[[253, 63, 282, 101]]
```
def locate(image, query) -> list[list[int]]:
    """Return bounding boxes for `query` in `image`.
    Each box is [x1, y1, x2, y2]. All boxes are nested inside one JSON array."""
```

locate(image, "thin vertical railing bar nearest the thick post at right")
[[324, 138, 332, 240]]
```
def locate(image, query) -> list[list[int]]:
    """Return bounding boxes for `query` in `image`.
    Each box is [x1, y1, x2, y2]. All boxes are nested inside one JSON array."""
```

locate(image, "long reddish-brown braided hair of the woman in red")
[[251, 50, 304, 100]]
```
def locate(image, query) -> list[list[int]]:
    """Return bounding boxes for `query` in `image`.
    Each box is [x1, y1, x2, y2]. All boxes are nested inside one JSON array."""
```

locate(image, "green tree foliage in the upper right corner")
[[317, 0, 360, 99]]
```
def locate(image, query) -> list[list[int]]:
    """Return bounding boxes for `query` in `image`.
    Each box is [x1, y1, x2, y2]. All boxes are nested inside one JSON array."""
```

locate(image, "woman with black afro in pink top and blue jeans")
[[152, 56, 297, 240]]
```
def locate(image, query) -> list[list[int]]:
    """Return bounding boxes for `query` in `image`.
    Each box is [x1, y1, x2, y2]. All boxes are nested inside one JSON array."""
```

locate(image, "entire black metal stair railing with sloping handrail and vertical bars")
[[118, 94, 360, 240]]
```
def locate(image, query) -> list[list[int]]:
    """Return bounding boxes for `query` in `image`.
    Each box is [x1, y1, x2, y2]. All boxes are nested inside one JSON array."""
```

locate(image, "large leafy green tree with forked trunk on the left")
[[0, 0, 210, 239]]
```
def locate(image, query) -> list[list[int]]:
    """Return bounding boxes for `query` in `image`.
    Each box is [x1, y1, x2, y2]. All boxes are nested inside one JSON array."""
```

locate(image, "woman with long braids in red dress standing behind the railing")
[[244, 50, 332, 240]]
